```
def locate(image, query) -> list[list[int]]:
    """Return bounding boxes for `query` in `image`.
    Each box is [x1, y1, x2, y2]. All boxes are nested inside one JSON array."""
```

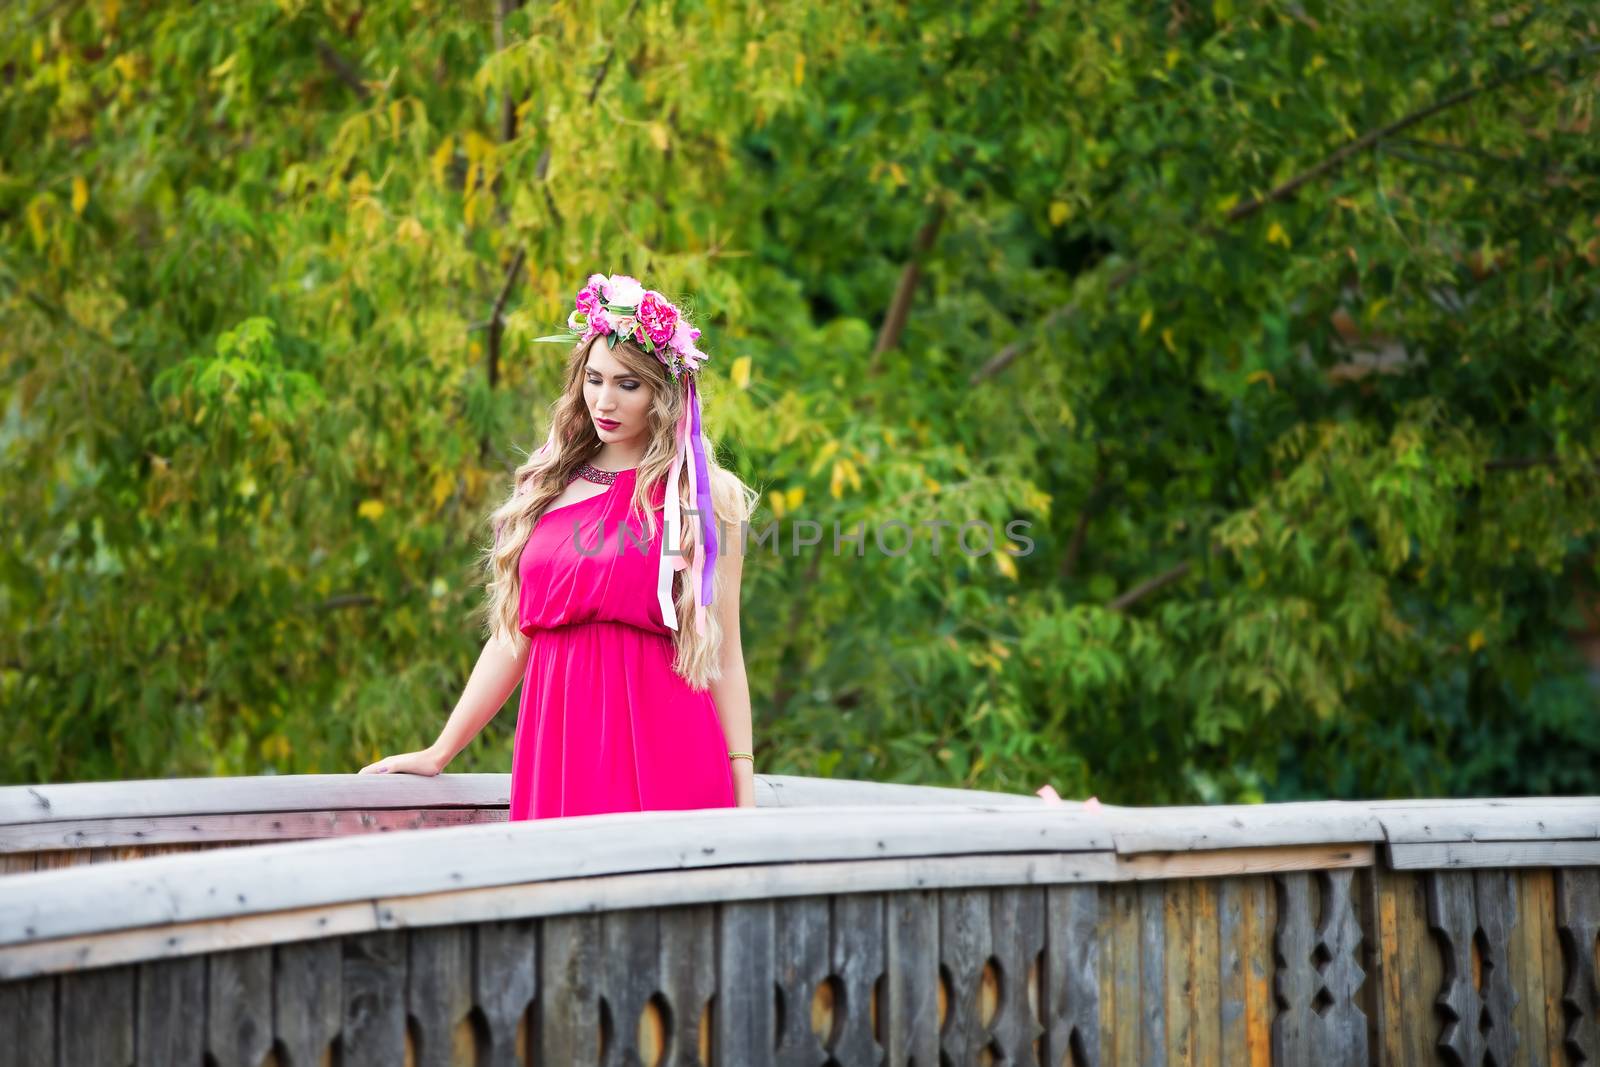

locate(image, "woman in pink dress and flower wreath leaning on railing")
[[362, 274, 755, 821]]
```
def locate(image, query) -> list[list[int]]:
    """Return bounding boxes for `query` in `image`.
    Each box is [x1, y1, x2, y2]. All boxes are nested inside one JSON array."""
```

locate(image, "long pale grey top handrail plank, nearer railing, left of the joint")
[[0, 806, 1110, 944]]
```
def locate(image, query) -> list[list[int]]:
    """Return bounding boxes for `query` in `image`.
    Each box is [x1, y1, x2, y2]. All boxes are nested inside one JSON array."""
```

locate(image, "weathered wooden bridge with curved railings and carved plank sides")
[[0, 774, 1600, 1067]]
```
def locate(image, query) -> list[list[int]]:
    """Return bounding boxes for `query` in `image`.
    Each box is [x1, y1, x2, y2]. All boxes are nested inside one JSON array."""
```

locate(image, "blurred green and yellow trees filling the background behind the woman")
[[0, 0, 1600, 803]]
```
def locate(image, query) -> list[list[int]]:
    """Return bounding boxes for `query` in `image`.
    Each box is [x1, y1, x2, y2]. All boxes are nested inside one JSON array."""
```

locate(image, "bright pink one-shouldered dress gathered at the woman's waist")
[[510, 470, 738, 821]]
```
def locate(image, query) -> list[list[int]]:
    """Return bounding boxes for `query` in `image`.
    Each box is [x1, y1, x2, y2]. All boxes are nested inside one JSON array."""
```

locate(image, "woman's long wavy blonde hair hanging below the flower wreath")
[[483, 339, 757, 689]]
